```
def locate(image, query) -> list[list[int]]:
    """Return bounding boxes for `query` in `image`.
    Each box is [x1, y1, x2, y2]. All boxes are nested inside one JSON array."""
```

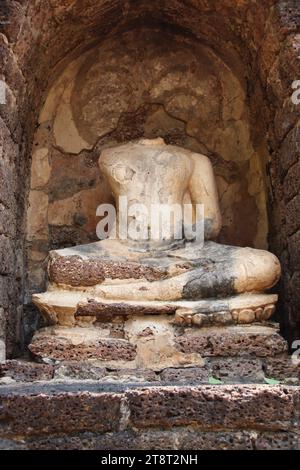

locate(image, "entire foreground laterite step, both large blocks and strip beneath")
[[0, 382, 300, 450]]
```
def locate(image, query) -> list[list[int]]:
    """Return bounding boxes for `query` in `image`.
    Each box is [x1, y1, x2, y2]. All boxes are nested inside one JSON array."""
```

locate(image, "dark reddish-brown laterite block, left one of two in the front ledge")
[[0, 392, 120, 437]]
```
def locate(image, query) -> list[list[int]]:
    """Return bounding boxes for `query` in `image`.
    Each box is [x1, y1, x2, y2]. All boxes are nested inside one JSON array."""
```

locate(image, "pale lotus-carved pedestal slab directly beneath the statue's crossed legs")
[[33, 288, 278, 327]]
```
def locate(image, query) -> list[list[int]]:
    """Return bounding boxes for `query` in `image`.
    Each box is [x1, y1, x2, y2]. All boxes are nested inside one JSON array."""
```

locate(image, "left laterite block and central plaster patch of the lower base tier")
[[28, 322, 204, 371]]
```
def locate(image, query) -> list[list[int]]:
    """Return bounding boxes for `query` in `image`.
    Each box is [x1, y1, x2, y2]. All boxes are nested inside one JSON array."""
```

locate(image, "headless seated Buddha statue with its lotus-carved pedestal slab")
[[33, 138, 280, 326]]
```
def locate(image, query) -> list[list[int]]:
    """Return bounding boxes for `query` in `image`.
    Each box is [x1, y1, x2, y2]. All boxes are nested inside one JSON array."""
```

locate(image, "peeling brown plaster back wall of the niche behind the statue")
[[27, 27, 268, 299]]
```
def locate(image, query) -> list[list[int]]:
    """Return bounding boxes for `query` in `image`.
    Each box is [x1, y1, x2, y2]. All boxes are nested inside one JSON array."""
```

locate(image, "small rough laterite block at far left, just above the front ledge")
[[0, 360, 54, 382]]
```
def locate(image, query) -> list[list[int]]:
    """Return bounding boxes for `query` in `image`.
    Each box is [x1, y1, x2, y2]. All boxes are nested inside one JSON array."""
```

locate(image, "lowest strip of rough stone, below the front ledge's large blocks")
[[0, 430, 300, 450]]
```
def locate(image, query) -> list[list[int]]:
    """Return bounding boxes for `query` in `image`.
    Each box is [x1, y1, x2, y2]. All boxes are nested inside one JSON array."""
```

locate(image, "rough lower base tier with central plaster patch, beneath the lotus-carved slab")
[[29, 322, 287, 371]]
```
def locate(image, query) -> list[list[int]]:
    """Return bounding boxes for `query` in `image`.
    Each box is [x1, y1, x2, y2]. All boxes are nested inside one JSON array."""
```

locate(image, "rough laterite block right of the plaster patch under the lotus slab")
[[175, 326, 287, 357]]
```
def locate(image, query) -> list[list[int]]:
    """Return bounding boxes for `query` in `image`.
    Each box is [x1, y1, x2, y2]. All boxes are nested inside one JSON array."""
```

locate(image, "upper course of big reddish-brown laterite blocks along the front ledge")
[[0, 381, 300, 439]]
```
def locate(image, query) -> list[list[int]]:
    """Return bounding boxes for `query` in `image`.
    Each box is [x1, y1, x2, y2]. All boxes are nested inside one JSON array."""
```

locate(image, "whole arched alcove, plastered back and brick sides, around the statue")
[[0, 0, 300, 354]]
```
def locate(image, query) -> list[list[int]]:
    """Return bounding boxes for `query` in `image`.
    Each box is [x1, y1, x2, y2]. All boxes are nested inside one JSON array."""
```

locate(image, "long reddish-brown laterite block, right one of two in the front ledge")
[[128, 385, 297, 431]]
